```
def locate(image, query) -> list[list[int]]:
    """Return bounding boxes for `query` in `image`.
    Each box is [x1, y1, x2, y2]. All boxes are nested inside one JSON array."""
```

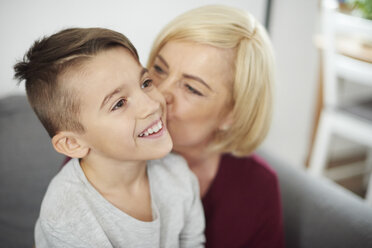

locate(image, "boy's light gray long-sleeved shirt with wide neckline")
[[35, 154, 205, 248]]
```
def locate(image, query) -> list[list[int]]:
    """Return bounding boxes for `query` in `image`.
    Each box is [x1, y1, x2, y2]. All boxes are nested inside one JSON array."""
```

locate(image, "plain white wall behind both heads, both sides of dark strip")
[[0, 0, 317, 169]]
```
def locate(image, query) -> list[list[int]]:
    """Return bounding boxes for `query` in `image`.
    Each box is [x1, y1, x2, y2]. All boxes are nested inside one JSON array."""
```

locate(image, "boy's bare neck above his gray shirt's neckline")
[[80, 157, 153, 221]]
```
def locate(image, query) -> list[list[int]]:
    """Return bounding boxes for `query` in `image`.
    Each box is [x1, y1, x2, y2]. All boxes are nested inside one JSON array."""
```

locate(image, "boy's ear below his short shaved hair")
[[52, 131, 89, 158]]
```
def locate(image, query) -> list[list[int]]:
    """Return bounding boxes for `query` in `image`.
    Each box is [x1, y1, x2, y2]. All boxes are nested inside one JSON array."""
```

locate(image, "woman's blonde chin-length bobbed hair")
[[148, 5, 274, 156]]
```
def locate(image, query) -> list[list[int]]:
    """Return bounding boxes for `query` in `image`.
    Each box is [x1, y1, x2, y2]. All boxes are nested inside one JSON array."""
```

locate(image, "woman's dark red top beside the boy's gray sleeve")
[[202, 155, 284, 248]]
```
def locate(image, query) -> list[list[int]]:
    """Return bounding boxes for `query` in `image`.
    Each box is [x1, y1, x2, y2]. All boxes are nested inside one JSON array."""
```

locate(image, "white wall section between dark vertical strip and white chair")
[[263, 0, 318, 167]]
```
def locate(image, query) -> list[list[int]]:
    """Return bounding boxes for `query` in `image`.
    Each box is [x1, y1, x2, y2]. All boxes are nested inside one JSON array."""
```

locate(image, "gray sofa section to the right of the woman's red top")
[[260, 151, 372, 248]]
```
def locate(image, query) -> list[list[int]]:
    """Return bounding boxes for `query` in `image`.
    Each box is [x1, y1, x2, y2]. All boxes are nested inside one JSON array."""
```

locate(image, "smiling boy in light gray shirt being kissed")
[[14, 28, 204, 248]]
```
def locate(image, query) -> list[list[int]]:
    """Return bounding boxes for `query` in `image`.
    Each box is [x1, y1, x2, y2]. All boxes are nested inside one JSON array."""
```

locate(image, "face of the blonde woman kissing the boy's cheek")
[[150, 41, 234, 153]]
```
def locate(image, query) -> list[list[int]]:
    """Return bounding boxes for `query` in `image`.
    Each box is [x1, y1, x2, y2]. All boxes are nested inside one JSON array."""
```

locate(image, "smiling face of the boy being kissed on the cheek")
[[70, 47, 172, 162]]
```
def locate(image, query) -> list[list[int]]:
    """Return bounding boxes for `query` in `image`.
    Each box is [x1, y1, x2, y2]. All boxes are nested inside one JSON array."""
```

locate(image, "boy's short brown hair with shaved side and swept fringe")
[[14, 28, 139, 137]]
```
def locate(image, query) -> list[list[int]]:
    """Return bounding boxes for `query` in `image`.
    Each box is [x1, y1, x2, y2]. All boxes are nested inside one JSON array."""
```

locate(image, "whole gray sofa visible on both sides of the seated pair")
[[0, 96, 372, 248]]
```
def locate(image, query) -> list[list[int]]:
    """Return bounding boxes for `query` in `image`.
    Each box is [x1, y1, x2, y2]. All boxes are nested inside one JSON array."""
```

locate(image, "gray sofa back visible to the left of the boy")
[[0, 95, 63, 248]]
